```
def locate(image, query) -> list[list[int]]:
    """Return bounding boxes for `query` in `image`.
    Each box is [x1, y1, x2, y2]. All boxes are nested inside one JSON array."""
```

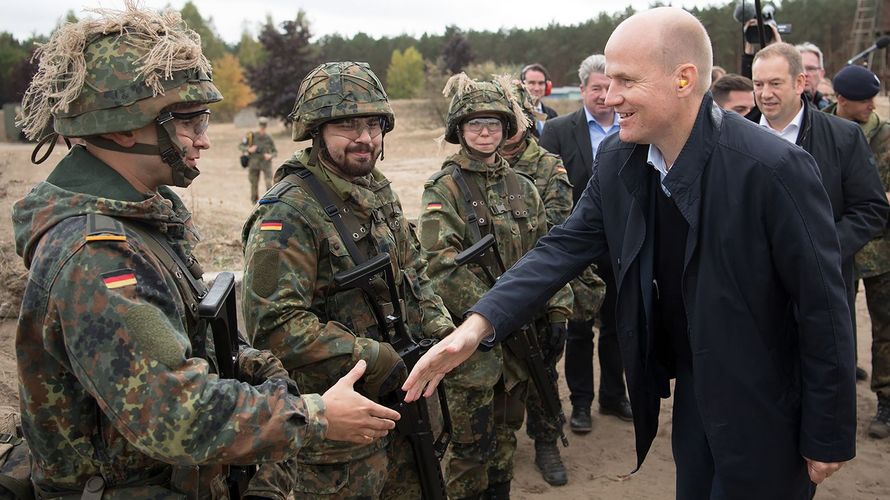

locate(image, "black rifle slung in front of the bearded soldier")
[[334, 252, 451, 500]]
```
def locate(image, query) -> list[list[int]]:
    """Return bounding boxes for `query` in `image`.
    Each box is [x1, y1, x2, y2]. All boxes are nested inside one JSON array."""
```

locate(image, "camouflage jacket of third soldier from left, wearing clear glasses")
[[420, 152, 572, 323]]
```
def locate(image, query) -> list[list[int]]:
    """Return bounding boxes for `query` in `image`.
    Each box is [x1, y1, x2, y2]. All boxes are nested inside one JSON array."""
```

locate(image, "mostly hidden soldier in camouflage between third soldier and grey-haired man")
[[499, 83, 606, 486]]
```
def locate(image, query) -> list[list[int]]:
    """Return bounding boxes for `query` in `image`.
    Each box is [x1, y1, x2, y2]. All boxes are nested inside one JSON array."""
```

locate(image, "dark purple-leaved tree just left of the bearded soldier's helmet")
[[247, 10, 318, 121]]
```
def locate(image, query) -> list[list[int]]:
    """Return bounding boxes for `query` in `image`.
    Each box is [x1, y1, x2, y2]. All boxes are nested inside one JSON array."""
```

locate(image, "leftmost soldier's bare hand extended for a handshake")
[[321, 360, 400, 444]]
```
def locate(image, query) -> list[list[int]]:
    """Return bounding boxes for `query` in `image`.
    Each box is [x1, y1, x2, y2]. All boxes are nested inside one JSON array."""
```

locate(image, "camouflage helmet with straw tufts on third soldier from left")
[[442, 73, 527, 144]]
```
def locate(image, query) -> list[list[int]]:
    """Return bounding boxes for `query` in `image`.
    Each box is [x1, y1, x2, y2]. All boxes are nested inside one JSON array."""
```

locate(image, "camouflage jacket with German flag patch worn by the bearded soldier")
[[242, 150, 454, 463]]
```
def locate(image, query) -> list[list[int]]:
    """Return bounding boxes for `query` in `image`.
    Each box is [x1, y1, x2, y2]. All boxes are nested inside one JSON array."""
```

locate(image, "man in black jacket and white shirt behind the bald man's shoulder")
[[752, 43, 887, 374]]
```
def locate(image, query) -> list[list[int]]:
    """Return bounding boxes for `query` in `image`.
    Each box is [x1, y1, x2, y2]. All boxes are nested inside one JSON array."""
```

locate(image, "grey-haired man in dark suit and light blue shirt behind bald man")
[[541, 54, 633, 433]]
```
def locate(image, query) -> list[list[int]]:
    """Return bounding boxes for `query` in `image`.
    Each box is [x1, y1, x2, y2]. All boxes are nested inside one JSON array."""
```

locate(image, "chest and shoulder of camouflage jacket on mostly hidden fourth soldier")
[[505, 137, 572, 230]]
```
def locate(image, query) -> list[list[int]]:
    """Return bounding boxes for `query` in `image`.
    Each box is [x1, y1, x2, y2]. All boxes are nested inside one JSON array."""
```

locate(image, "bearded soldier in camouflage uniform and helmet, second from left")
[[243, 62, 454, 499]]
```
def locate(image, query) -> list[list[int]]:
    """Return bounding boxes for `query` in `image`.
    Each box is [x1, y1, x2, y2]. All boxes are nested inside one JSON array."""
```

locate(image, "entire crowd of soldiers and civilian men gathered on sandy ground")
[[0, 2, 890, 499]]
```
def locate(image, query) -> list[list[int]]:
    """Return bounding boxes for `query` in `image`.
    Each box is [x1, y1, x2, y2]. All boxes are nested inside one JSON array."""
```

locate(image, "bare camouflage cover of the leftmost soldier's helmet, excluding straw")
[[53, 33, 222, 137]]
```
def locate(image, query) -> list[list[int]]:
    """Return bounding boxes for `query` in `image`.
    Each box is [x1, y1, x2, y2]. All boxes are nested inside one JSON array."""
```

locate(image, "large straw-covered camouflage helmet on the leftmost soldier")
[[21, 2, 222, 138]]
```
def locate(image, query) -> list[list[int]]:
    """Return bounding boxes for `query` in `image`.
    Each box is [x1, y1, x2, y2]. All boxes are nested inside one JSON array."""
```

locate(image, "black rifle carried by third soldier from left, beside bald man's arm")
[[454, 234, 569, 446]]
